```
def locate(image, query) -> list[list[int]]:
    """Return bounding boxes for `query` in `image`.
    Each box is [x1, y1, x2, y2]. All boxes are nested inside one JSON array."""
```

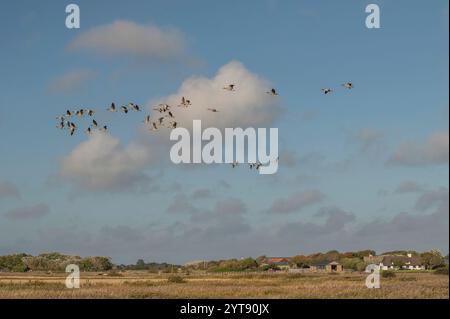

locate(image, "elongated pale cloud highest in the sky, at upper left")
[[68, 20, 185, 60]]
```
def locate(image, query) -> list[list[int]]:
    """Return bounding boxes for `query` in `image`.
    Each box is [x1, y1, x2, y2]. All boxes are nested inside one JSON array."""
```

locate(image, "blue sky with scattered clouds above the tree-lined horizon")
[[0, 0, 449, 262]]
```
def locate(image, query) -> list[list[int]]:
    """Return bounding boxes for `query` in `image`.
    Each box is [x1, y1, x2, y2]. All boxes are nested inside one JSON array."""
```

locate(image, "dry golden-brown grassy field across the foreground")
[[0, 272, 449, 298]]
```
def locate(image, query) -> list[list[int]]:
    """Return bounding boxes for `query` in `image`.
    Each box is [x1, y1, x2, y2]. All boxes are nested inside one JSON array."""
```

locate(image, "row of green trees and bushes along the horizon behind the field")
[[0, 250, 448, 273]]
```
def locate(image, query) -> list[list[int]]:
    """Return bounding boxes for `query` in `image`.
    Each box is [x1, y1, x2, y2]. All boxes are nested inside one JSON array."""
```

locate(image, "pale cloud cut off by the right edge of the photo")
[[388, 131, 449, 166]]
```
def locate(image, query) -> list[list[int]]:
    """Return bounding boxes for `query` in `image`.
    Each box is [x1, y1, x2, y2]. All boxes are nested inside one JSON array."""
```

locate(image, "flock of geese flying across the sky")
[[57, 82, 353, 170]]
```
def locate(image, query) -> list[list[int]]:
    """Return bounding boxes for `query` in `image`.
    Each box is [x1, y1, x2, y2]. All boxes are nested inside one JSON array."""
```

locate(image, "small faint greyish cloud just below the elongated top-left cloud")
[[48, 69, 95, 94]]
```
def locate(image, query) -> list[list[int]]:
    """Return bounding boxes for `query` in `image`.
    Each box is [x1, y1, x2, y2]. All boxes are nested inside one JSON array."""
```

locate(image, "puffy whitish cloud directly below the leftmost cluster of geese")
[[60, 132, 153, 191]]
